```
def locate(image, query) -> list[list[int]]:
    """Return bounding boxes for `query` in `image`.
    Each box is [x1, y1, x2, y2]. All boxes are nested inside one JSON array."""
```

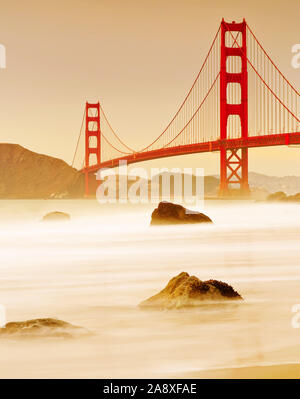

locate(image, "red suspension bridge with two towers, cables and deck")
[[73, 19, 300, 196]]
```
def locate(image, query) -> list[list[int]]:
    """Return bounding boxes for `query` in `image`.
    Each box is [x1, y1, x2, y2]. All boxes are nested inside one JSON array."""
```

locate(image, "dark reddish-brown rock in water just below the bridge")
[[151, 201, 212, 225]]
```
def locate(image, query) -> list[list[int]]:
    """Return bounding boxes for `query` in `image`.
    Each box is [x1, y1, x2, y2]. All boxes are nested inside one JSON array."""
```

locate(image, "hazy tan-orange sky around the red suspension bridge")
[[0, 0, 300, 175]]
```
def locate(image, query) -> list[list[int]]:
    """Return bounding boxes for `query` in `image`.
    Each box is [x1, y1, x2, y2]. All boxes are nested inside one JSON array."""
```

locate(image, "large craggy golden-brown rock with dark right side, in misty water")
[[139, 272, 243, 309]]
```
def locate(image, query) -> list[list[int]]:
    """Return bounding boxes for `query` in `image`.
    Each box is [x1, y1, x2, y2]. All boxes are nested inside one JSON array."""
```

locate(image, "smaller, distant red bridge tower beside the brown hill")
[[85, 102, 101, 196]]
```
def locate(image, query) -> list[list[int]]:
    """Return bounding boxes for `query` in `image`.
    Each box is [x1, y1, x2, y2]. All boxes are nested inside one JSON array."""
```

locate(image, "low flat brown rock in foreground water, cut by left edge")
[[0, 318, 88, 338]]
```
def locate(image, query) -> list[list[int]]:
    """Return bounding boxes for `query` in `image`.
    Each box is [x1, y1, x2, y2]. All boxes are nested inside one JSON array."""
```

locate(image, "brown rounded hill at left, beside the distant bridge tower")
[[0, 144, 84, 199]]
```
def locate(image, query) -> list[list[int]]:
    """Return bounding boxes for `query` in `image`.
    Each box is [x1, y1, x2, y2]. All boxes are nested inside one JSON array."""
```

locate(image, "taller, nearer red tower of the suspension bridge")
[[219, 19, 250, 196]]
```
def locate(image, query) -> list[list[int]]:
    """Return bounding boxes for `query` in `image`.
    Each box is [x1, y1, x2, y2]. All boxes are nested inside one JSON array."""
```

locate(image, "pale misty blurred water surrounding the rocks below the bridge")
[[0, 200, 300, 378]]
